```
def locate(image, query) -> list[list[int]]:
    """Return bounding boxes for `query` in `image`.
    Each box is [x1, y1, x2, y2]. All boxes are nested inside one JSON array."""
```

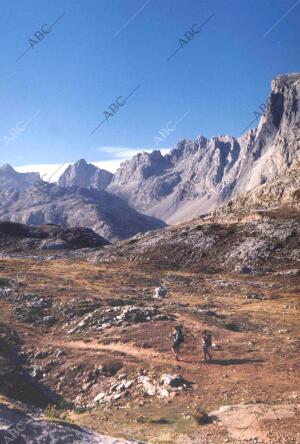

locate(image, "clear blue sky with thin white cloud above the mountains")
[[0, 0, 300, 179]]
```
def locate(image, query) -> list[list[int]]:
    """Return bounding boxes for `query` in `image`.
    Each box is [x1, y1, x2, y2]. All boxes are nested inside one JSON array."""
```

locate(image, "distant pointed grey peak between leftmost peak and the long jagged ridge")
[[58, 159, 113, 190]]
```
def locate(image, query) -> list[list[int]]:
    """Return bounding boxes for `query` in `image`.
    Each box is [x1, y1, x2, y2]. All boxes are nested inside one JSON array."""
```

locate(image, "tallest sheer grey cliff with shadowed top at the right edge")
[[235, 74, 300, 193]]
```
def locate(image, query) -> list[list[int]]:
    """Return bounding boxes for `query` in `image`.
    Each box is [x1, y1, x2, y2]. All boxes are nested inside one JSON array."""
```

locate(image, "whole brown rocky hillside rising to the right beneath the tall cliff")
[[87, 162, 300, 270]]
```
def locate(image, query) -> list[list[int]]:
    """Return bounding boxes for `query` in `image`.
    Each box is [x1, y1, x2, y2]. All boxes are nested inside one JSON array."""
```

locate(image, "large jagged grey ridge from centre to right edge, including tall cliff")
[[108, 74, 300, 223]]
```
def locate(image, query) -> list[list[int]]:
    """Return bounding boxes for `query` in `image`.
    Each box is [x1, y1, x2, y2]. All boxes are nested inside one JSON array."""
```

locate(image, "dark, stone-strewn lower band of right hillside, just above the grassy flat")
[[83, 213, 300, 273]]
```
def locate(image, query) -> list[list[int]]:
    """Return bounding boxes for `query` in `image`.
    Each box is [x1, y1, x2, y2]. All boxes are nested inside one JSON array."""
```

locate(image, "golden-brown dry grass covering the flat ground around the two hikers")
[[0, 259, 300, 444]]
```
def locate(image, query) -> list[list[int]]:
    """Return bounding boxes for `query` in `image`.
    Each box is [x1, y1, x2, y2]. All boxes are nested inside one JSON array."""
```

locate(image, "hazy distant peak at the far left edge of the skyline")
[[0, 164, 40, 190]]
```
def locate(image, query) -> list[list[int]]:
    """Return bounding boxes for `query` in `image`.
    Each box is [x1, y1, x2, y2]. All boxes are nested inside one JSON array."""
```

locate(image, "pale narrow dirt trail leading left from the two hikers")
[[49, 340, 199, 370]]
